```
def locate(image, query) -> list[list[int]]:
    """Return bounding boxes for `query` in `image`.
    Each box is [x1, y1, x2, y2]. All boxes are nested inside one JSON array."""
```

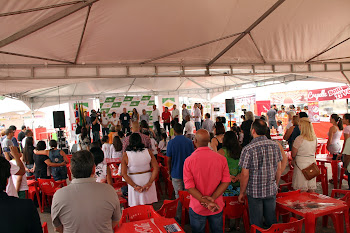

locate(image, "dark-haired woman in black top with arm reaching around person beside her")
[[34, 141, 66, 179]]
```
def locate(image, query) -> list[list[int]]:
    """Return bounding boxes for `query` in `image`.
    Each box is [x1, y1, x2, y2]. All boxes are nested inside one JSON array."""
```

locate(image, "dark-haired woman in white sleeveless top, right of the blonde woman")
[[327, 114, 343, 159]]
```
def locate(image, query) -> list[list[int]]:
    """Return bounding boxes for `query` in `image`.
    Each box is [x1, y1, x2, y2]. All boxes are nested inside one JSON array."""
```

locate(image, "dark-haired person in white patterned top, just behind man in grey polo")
[[90, 147, 112, 185]]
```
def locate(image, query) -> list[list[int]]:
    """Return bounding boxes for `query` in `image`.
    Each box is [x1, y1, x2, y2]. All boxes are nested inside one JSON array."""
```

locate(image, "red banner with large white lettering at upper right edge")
[[308, 86, 350, 102]]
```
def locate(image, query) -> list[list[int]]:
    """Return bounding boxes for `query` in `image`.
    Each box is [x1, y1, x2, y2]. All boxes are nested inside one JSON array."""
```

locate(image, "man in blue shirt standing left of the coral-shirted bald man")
[[166, 123, 194, 221]]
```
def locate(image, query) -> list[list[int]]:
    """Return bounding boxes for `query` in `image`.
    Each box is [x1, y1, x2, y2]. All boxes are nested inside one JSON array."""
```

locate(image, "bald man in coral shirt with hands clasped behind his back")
[[183, 129, 231, 233]]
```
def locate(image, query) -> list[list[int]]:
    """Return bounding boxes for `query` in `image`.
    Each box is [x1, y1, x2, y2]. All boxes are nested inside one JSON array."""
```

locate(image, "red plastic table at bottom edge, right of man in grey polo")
[[115, 218, 185, 233]]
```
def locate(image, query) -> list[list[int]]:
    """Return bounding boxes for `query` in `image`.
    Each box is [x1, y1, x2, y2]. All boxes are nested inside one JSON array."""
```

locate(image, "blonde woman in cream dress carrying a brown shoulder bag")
[[292, 117, 317, 192]]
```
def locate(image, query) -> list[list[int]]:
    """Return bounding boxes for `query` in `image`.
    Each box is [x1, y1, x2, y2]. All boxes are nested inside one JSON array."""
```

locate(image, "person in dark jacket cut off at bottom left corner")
[[0, 156, 43, 233]]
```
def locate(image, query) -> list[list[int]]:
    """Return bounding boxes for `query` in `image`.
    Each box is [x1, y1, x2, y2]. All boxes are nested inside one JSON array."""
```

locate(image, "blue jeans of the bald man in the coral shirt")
[[188, 208, 223, 233]]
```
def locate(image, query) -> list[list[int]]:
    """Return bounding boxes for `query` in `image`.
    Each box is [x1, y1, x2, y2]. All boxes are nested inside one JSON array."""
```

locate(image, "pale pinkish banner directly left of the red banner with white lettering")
[[270, 90, 308, 106]]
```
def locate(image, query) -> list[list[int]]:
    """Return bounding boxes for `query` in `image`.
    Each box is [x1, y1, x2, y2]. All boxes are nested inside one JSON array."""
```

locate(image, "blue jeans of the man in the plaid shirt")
[[248, 195, 277, 228]]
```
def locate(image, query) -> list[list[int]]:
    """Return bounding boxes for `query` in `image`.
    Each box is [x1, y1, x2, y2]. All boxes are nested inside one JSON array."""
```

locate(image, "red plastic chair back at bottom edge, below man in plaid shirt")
[[251, 218, 304, 233]]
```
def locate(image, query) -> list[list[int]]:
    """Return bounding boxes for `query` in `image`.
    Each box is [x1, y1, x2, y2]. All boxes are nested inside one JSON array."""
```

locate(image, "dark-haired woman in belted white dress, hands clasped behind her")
[[121, 133, 159, 206]]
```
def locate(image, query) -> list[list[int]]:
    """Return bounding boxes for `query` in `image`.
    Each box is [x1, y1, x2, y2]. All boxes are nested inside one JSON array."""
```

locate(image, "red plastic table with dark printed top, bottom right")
[[276, 192, 350, 233]]
